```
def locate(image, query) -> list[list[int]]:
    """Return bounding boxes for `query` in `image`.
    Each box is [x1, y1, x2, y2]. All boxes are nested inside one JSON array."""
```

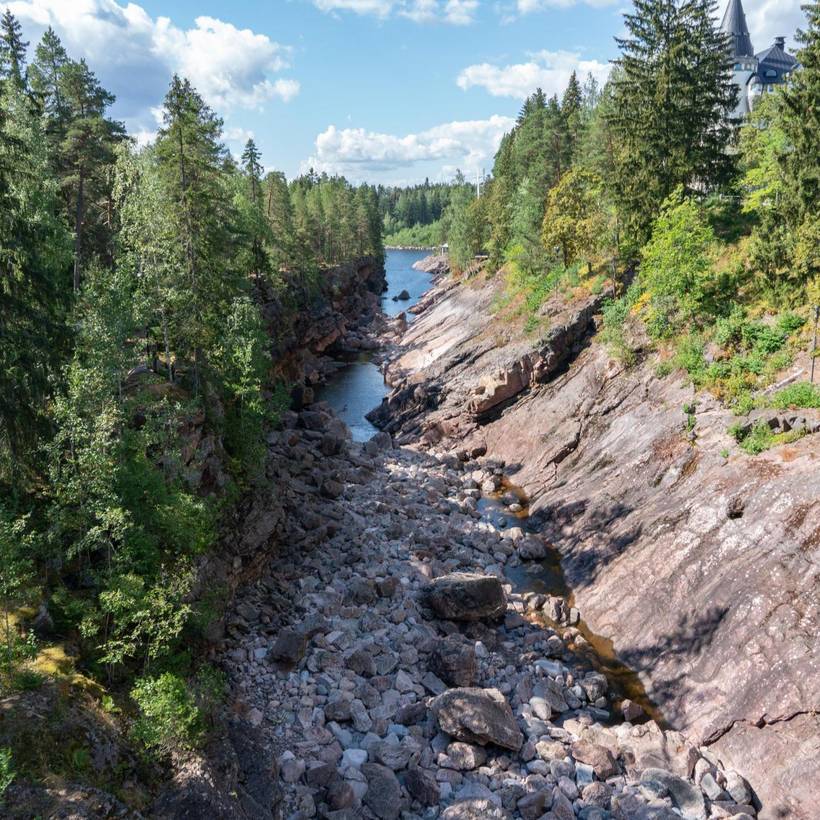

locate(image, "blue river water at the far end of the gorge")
[[316, 251, 432, 441]]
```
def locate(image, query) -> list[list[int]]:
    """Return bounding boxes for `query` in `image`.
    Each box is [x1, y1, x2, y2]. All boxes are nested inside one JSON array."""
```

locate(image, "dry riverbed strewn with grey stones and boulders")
[[218, 405, 756, 820]]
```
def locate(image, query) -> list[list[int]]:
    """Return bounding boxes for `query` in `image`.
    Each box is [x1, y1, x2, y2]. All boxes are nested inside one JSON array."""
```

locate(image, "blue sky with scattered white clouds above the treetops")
[[8, 0, 803, 185]]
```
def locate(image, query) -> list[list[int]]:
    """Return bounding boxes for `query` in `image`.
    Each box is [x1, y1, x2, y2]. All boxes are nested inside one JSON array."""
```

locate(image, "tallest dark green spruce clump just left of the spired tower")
[[611, 0, 737, 242]]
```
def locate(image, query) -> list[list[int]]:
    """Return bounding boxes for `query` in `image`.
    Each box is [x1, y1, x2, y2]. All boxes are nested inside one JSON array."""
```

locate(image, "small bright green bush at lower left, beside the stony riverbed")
[[131, 672, 204, 755]]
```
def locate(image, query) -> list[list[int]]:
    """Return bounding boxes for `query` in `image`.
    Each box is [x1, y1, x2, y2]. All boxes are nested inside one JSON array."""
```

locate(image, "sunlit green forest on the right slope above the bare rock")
[[444, 0, 820, 426]]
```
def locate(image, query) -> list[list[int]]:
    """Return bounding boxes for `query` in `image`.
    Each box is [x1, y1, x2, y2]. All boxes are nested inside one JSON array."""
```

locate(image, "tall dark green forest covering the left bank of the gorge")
[[0, 10, 383, 760]]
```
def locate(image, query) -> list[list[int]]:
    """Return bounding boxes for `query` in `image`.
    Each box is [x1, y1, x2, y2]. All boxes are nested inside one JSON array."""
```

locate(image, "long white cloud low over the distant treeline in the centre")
[[302, 116, 515, 182]]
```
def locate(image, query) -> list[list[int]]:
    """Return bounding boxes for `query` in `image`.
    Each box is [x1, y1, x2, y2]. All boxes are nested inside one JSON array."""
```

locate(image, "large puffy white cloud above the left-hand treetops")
[[8, 0, 299, 138]]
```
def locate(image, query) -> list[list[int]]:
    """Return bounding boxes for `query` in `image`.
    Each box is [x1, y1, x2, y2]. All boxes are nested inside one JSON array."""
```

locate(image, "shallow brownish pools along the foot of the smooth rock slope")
[[478, 484, 668, 728]]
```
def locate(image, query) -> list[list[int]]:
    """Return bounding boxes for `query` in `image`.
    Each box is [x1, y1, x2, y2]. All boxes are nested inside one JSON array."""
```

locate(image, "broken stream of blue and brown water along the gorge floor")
[[317, 250, 667, 727]]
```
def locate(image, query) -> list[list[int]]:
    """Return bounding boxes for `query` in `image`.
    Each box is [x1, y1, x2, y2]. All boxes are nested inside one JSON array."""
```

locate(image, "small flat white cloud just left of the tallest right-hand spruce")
[[456, 51, 609, 99]]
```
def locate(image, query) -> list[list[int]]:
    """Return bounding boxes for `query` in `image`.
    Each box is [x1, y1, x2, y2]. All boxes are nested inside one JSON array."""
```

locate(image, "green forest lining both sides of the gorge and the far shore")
[[0, 0, 820, 800]]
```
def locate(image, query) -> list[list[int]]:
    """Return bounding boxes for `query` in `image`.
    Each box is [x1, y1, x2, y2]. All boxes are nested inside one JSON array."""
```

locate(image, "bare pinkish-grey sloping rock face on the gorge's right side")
[[373, 266, 820, 818]]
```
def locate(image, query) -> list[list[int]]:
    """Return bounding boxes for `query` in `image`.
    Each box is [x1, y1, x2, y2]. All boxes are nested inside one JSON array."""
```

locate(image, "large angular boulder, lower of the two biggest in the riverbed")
[[430, 688, 524, 752]]
